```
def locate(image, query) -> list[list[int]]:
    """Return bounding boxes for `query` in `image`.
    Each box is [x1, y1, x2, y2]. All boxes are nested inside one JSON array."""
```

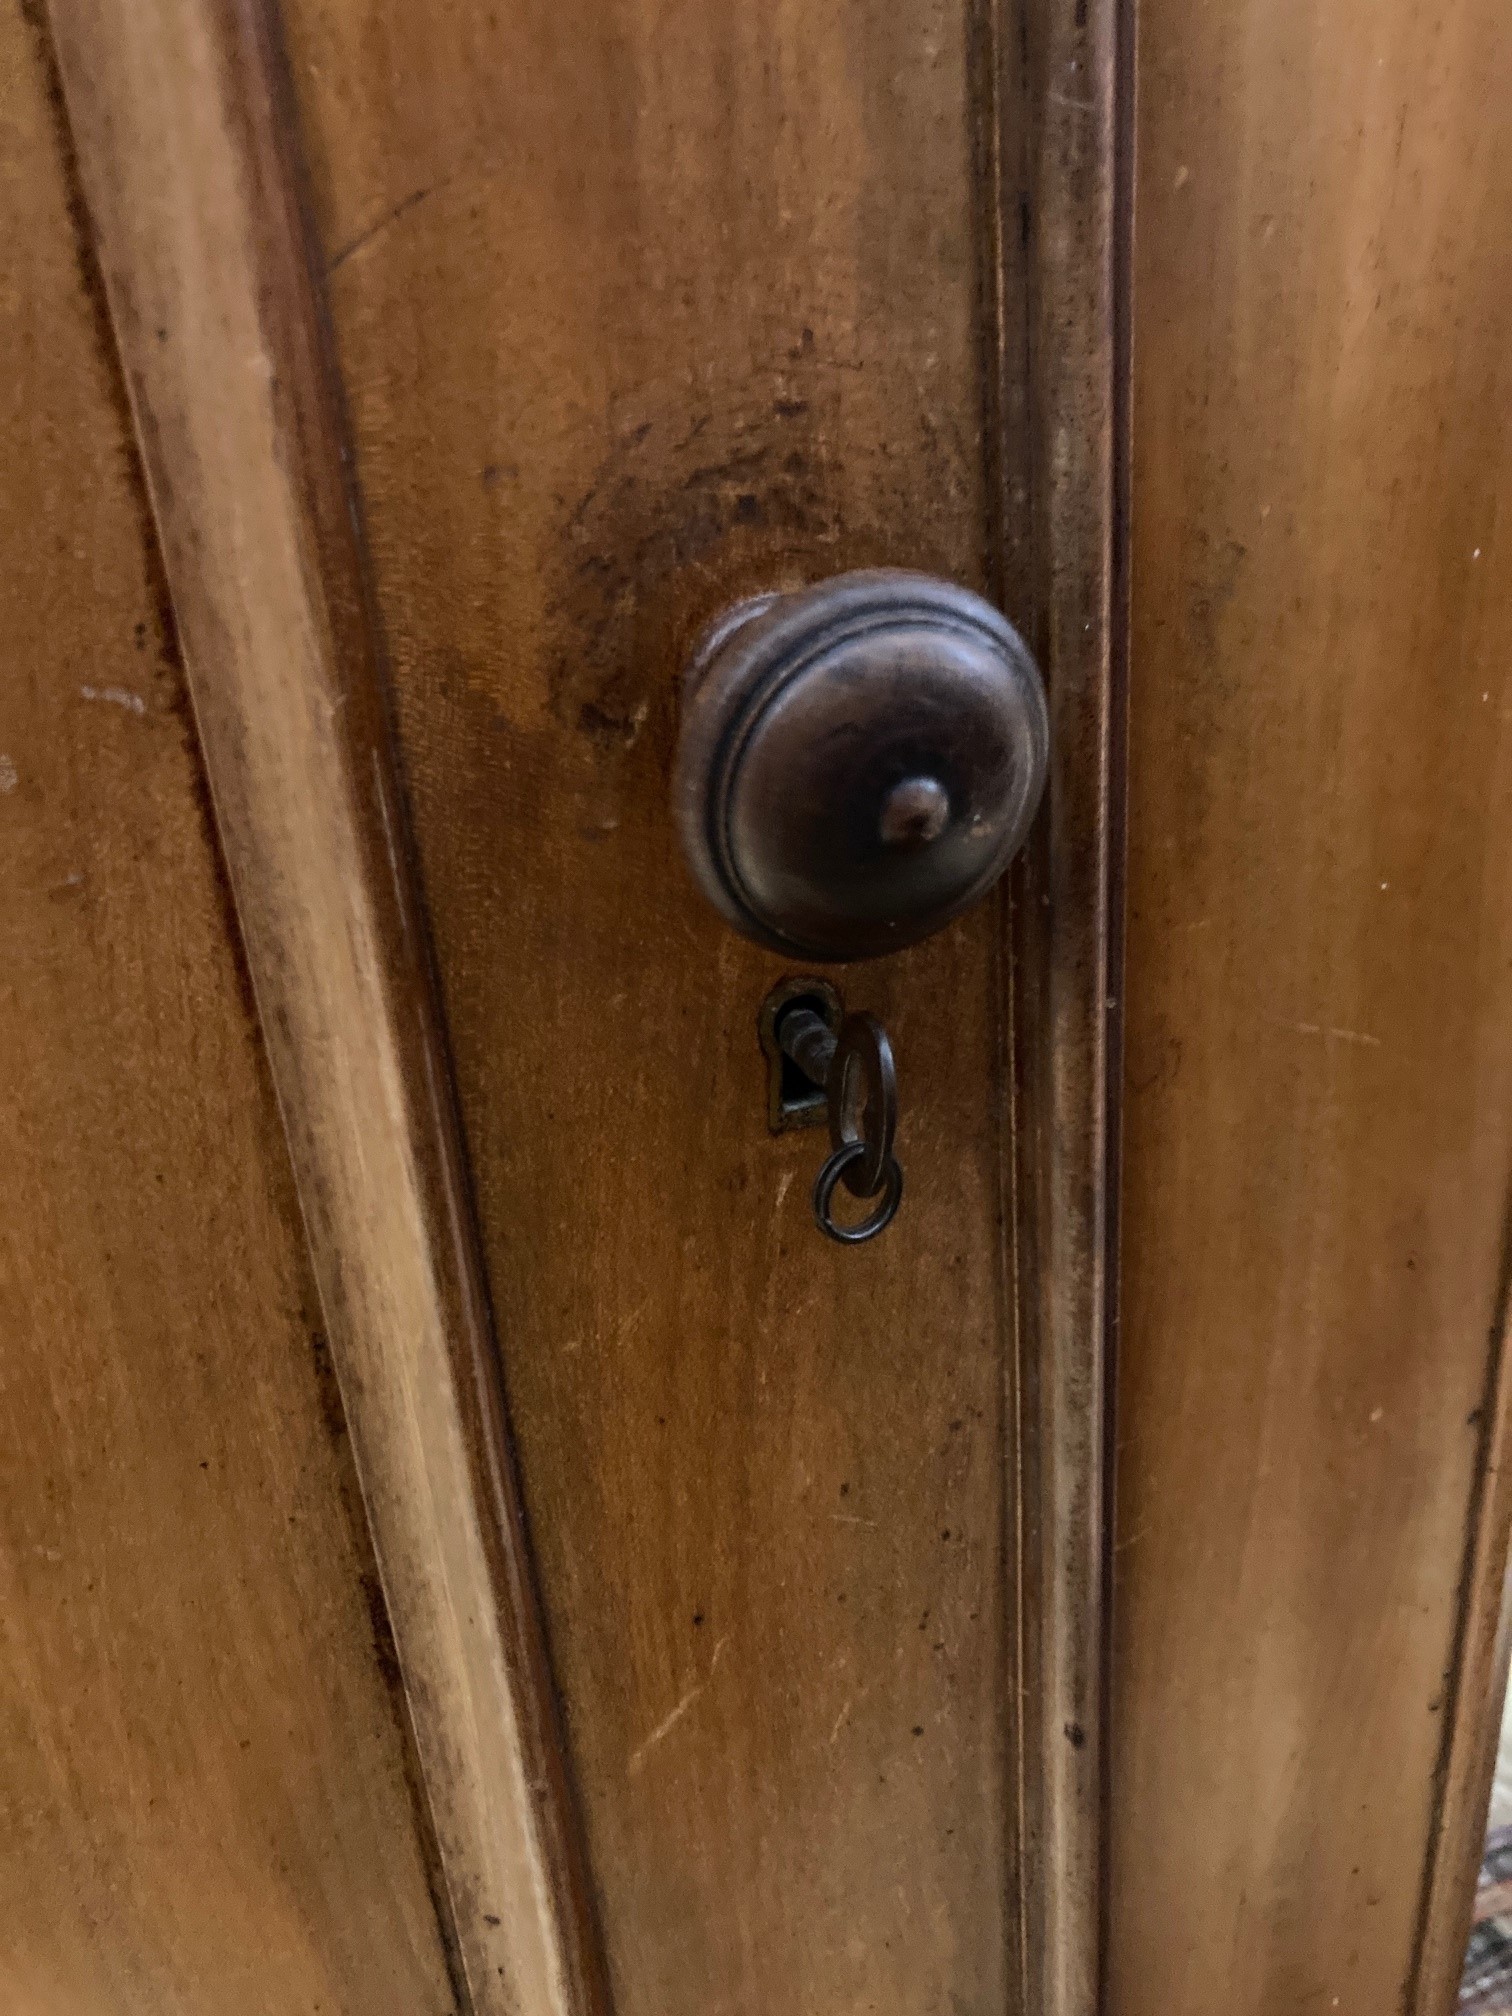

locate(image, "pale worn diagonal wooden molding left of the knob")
[[50, 0, 605, 2016]]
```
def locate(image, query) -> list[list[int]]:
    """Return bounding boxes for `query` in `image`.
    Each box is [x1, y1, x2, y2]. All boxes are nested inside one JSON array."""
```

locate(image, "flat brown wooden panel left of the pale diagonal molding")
[[0, 8, 458, 2016]]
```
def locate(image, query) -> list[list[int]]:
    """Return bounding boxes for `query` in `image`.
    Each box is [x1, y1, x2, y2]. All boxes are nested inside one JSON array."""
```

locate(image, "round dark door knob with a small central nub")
[[673, 569, 1050, 960]]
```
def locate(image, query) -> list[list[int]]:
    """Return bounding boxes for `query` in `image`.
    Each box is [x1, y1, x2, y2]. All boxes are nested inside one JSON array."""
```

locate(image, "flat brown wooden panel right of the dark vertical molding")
[[1109, 0, 1512, 2016]]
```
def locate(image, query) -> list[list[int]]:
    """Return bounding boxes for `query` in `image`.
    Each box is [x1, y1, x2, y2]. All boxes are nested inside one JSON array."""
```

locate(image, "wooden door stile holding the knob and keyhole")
[[276, 0, 1016, 2016]]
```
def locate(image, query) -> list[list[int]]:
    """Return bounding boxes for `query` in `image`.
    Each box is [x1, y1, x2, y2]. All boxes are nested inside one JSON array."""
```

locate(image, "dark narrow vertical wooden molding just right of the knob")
[[974, 0, 1135, 2016]]
